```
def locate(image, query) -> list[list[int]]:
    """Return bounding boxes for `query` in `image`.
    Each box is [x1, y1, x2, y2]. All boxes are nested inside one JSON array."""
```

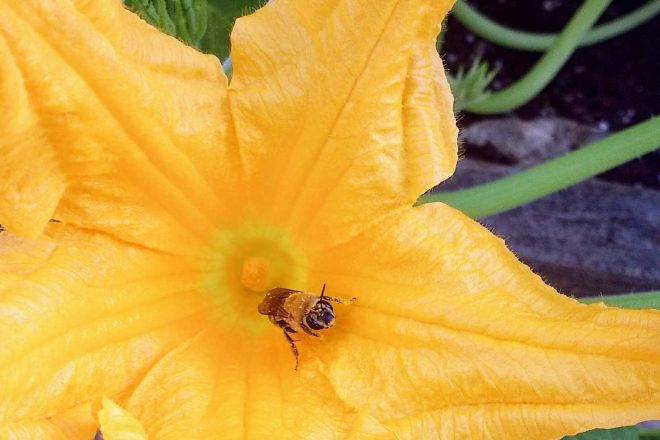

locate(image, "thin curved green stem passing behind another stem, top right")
[[452, 0, 660, 52]]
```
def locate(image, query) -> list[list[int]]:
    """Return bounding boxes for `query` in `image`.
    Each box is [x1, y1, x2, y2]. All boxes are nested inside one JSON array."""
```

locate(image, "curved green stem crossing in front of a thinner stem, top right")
[[467, 0, 612, 114]]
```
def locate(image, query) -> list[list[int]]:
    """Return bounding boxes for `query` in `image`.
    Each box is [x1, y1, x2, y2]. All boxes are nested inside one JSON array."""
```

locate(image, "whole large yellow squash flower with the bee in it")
[[0, 0, 660, 440]]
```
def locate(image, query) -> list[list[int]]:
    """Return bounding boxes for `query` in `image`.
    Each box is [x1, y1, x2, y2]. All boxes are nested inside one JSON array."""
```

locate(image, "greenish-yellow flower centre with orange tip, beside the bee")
[[201, 221, 307, 329]]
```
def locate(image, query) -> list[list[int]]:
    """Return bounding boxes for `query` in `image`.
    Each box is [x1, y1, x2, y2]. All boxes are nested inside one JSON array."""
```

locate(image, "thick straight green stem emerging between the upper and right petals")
[[418, 116, 660, 217]]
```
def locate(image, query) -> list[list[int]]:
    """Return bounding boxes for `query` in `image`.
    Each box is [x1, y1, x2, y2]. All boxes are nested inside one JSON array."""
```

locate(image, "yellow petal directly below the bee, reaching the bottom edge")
[[125, 329, 364, 440]]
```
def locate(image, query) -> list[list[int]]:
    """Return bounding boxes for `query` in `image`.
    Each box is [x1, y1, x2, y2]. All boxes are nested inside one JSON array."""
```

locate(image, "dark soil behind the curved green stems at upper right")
[[443, 0, 660, 189]]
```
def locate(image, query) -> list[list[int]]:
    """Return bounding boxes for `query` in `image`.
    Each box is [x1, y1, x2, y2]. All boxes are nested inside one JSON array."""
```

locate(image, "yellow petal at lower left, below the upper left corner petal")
[[0, 224, 208, 429]]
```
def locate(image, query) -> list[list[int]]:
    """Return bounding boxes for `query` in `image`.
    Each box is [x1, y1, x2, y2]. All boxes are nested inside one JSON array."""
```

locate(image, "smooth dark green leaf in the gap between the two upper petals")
[[200, 0, 266, 61]]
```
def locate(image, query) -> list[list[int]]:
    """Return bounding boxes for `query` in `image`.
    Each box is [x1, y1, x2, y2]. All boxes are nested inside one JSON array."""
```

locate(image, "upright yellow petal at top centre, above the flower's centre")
[[229, 0, 456, 246]]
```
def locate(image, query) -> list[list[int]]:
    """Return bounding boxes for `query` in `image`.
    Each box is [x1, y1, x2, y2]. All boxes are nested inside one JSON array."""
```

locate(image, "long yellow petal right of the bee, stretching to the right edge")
[[307, 204, 660, 438]]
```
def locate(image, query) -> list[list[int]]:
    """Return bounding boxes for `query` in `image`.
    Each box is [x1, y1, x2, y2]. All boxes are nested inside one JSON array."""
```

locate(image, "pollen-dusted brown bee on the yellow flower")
[[258, 284, 355, 370]]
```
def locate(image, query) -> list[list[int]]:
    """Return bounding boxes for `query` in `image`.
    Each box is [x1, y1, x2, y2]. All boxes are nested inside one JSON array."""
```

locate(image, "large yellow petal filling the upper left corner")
[[0, 0, 237, 252]]
